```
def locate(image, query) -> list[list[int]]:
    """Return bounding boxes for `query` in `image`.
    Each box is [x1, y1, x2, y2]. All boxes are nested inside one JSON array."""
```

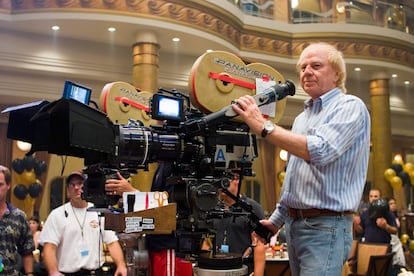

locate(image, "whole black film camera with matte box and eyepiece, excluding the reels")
[[3, 81, 295, 244]]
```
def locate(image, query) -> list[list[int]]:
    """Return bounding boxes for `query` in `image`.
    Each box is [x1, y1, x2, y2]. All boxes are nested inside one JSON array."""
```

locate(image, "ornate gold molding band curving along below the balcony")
[[0, 0, 414, 68]]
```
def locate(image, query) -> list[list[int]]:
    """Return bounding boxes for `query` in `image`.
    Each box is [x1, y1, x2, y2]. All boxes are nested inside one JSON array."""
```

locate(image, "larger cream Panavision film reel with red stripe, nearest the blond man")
[[189, 51, 286, 123]]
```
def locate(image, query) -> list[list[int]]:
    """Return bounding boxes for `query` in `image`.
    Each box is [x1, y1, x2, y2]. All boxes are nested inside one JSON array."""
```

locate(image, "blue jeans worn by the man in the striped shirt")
[[285, 215, 353, 276]]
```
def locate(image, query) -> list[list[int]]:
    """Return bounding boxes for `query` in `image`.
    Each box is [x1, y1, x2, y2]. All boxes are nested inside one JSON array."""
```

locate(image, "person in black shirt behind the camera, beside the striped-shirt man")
[[213, 173, 266, 276]]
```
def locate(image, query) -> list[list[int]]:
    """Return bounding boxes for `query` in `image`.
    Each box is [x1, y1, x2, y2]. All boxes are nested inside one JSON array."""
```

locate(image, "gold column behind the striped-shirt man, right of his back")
[[370, 74, 393, 197]]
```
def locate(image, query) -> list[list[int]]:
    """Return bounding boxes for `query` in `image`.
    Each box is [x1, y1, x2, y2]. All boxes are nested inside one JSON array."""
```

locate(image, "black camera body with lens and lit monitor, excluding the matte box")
[[84, 89, 257, 229]]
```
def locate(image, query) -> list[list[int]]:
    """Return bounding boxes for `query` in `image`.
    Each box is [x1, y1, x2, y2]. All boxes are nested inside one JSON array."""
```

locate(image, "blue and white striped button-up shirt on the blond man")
[[270, 88, 371, 227]]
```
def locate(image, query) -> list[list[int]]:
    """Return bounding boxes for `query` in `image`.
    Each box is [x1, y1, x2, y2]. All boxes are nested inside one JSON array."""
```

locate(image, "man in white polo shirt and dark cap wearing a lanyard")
[[39, 172, 127, 276]]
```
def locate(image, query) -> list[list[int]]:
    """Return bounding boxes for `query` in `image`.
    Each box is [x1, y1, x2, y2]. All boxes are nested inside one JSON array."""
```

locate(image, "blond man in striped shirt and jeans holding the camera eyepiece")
[[232, 42, 371, 276]]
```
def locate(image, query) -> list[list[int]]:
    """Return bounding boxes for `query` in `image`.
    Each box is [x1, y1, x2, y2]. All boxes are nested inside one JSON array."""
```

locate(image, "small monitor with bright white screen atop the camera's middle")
[[151, 94, 183, 121]]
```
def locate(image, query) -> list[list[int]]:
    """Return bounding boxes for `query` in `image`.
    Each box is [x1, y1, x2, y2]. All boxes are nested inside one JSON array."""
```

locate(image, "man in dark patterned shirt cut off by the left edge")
[[0, 165, 35, 276]]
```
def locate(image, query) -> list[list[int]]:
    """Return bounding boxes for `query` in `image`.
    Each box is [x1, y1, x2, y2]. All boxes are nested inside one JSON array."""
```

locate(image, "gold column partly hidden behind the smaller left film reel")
[[131, 32, 160, 192]]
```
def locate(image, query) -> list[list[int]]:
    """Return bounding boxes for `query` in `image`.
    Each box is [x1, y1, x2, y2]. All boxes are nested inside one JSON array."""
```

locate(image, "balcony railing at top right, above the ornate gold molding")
[[228, 0, 414, 34]]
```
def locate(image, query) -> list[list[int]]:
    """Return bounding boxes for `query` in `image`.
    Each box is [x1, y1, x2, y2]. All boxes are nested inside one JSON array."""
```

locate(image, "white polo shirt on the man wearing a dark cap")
[[39, 202, 118, 273]]
